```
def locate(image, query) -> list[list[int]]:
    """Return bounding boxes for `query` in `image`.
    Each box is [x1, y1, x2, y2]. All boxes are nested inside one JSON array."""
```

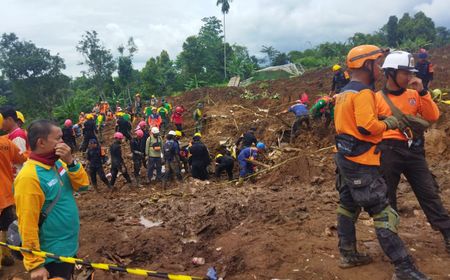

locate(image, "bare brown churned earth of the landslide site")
[[2, 47, 450, 280]]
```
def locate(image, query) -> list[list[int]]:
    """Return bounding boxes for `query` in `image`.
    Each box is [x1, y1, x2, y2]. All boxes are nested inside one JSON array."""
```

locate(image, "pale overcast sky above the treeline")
[[0, 0, 450, 76]]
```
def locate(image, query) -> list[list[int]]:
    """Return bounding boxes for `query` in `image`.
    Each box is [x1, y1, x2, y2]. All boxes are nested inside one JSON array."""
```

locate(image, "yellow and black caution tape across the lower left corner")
[[0, 242, 209, 280]]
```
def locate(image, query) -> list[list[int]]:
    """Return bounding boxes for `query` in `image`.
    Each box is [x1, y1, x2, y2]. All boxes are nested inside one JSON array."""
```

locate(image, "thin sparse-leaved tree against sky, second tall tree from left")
[[76, 30, 116, 100]]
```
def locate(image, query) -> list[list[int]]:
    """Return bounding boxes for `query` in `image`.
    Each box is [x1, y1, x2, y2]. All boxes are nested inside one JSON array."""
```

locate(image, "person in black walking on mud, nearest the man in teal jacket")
[[86, 139, 112, 191]]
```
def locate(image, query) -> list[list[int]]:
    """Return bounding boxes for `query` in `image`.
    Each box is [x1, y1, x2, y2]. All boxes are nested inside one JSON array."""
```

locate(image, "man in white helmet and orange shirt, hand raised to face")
[[376, 51, 450, 253]]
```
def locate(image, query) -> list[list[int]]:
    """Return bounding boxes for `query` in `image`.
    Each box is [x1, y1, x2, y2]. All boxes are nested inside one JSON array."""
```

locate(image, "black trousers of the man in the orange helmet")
[[335, 153, 408, 262]]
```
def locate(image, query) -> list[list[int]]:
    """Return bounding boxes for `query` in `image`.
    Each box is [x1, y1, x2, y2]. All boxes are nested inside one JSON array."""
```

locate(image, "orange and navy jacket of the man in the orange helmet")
[[334, 81, 386, 166]]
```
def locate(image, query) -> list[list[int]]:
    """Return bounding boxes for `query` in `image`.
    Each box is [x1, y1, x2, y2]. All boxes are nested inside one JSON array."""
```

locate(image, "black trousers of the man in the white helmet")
[[381, 140, 450, 230]]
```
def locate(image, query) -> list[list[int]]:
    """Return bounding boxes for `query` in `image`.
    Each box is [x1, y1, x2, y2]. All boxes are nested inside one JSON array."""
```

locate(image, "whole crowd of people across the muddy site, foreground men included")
[[0, 45, 444, 280]]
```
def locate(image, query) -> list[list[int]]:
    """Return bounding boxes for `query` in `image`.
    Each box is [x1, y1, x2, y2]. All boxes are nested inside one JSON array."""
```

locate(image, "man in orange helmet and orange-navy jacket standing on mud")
[[335, 45, 428, 280]]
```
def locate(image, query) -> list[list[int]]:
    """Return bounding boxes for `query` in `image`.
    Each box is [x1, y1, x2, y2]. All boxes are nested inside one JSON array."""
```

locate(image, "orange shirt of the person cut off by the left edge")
[[0, 135, 26, 212]]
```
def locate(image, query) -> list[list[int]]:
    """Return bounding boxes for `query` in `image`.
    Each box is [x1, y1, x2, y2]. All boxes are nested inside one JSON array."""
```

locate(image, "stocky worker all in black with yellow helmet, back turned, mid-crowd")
[[189, 132, 211, 181]]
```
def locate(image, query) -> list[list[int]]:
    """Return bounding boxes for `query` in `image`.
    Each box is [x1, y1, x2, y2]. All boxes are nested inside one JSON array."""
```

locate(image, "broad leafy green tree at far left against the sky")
[[0, 33, 70, 117]]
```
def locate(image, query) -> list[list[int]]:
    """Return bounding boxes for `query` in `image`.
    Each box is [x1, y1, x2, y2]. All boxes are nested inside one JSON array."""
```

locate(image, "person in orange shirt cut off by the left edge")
[[0, 114, 27, 268]]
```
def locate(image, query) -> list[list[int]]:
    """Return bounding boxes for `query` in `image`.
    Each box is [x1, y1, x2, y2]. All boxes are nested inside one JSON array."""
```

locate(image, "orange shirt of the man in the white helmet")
[[375, 89, 439, 141]]
